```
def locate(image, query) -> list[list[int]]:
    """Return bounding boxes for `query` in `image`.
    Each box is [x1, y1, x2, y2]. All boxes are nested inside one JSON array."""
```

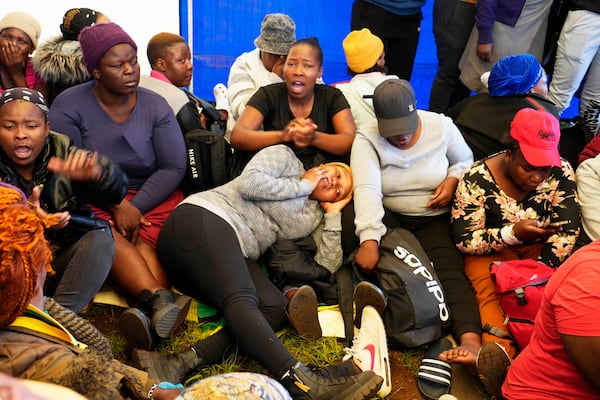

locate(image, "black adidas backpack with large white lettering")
[[355, 228, 451, 349]]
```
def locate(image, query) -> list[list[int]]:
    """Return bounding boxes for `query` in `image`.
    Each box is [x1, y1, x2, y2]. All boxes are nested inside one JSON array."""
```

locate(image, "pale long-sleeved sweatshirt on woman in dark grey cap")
[[350, 110, 473, 243]]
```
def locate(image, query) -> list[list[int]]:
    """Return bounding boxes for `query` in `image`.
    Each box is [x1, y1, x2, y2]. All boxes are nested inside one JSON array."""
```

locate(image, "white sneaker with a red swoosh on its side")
[[344, 306, 392, 398]]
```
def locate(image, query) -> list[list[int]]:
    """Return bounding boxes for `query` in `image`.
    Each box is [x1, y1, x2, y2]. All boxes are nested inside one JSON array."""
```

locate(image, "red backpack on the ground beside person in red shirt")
[[484, 259, 554, 350]]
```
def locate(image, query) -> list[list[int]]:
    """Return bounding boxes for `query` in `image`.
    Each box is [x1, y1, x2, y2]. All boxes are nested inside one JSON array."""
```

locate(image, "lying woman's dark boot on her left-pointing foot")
[[131, 349, 204, 384]]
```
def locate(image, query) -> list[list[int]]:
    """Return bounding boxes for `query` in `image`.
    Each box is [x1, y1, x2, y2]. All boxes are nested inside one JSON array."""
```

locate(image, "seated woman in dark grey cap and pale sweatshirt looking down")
[[351, 79, 481, 382]]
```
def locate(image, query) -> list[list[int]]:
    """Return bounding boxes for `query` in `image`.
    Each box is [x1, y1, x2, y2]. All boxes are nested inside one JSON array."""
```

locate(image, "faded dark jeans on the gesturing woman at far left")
[[44, 229, 115, 313]]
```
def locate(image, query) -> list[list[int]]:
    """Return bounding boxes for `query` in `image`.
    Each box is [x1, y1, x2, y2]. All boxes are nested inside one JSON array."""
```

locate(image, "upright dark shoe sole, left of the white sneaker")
[[288, 285, 323, 339]]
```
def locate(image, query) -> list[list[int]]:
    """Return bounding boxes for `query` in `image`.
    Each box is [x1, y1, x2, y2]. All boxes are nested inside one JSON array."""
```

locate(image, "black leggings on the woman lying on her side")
[[157, 204, 296, 377]]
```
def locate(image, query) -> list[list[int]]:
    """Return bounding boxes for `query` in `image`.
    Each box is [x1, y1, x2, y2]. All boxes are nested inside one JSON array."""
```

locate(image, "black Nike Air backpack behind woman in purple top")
[[179, 91, 233, 196]]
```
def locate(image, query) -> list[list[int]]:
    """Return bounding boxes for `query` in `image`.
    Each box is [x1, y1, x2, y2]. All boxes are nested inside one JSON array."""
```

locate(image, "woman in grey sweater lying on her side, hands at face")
[[132, 145, 382, 400]]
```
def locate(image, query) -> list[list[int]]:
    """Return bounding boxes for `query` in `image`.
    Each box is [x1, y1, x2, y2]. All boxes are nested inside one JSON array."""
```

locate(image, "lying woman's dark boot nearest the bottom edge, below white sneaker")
[[281, 362, 383, 400]]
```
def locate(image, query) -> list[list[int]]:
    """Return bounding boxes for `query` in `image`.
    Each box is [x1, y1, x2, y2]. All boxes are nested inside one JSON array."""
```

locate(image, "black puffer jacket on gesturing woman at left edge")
[[0, 132, 128, 247]]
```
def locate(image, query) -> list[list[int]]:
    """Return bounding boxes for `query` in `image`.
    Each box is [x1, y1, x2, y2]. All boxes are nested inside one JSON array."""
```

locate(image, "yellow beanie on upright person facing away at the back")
[[342, 28, 383, 73]]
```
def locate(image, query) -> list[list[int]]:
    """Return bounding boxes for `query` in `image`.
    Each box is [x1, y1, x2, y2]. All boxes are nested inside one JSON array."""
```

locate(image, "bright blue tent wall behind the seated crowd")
[[180, 0, 437, 108]]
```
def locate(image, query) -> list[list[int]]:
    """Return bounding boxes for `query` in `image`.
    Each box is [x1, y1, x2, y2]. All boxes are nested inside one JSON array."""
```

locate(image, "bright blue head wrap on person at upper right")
[[488, 54, 544, 96]]
